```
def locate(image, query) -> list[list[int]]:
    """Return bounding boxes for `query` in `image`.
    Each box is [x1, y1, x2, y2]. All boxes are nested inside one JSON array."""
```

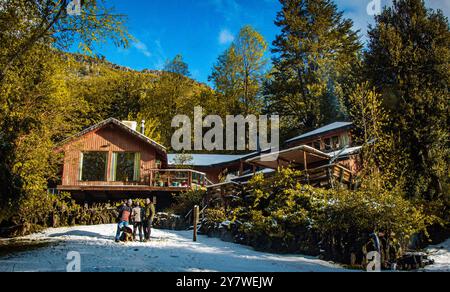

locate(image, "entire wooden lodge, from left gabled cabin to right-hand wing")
[[57, 118, 361, 207]]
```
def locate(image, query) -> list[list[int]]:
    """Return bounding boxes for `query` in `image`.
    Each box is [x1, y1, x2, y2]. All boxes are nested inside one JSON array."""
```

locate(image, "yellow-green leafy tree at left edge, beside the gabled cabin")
[[0, 46, 80, 221]]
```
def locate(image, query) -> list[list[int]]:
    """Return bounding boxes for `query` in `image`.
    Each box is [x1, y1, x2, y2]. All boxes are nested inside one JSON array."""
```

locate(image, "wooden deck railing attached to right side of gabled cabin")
[[146, 169, 208, 188]]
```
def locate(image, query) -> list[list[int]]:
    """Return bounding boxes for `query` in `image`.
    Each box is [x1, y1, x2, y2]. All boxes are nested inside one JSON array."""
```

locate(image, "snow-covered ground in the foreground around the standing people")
[[0, 225, 343, 272]]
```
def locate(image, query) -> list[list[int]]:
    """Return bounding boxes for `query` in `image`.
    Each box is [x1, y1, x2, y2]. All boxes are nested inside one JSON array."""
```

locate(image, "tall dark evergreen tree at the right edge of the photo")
[[365, 0, 450, 199]]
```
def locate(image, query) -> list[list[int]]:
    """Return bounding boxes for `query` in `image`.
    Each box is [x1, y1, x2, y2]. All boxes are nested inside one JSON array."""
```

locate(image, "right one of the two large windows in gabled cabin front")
[[111, 152, 141, 182]]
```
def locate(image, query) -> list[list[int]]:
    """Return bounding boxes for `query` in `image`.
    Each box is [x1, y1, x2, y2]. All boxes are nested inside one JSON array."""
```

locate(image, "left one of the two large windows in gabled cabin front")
[[80, 152, 108, 181]]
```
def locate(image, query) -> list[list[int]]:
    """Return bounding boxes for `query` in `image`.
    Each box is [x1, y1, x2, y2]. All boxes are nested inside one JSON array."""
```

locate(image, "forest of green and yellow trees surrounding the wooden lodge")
[[0, 0, 450, 258]]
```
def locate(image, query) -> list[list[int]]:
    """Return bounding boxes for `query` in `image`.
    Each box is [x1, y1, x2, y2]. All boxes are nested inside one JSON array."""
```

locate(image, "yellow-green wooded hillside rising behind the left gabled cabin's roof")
[[62, 54, 215, 145]]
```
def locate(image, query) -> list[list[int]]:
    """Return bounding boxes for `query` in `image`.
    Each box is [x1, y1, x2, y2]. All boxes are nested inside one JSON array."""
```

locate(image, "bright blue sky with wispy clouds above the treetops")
[[92, 0, 450, 82]]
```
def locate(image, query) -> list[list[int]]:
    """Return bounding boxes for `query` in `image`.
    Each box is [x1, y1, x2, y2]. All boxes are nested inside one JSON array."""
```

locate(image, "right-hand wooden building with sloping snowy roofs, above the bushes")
[[208, 122, 362, 197]]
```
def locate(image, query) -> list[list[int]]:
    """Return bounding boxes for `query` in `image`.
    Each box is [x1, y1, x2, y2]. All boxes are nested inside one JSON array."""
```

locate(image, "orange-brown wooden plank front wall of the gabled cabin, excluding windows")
[[62, 124, 167, 186]]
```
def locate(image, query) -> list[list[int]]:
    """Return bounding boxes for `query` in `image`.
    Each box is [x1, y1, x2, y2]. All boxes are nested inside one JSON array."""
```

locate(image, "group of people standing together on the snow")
[[116, 199, 155, 242]]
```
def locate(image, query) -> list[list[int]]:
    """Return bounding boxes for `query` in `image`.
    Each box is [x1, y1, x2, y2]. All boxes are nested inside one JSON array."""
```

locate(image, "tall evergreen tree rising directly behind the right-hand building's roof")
[[267, 0, 361, 138]]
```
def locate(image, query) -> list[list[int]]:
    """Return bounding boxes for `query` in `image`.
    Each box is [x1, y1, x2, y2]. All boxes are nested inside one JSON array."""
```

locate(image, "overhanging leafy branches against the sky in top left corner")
[[0, 0, 131, 82]]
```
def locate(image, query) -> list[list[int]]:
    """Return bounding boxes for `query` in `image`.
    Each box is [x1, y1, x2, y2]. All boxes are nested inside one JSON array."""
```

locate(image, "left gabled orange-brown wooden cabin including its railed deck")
[[57, 118, 206, 202]]
